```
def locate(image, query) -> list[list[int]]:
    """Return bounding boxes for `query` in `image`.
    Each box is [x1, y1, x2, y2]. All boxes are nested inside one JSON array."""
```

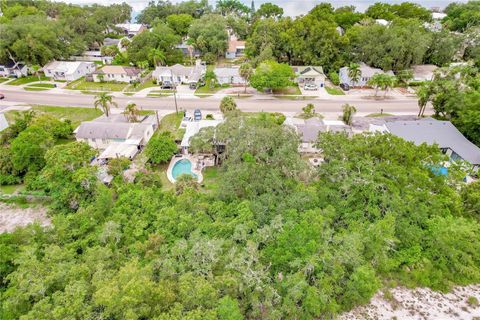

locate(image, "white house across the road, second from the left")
[[43, 61, 95, 81]]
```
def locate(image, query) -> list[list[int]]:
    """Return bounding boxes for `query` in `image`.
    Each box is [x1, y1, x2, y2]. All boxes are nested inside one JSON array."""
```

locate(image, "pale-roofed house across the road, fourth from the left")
[[152, 60, 207, 84]]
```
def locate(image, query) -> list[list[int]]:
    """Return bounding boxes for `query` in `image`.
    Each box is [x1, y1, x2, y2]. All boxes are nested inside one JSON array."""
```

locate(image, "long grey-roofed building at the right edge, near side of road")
[[370, 118, 480, 172]]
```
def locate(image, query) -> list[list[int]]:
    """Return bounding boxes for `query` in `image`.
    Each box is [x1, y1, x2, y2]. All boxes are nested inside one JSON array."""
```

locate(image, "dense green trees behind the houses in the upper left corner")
[[0, 1, 132, 65]]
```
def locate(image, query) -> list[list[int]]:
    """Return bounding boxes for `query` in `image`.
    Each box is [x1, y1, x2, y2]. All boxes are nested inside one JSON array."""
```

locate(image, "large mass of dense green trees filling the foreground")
[[0, 114, 480, 319]]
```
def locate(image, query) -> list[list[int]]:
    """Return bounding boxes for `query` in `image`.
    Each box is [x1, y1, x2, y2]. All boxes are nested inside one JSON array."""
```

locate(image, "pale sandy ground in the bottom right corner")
[[338, 285, 480, 320]]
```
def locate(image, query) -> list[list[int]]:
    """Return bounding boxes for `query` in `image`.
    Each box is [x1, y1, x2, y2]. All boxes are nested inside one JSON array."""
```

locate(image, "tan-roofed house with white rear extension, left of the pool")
[[74, 114, 156, 160]]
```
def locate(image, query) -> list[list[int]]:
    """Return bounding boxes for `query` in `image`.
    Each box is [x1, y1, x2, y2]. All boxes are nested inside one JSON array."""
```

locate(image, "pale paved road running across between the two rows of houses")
[[0, 86, 426, 114]]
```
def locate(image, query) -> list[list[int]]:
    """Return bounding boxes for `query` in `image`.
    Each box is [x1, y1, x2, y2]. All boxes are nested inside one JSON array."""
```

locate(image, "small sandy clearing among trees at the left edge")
[[0, 203, 52, 233]]
